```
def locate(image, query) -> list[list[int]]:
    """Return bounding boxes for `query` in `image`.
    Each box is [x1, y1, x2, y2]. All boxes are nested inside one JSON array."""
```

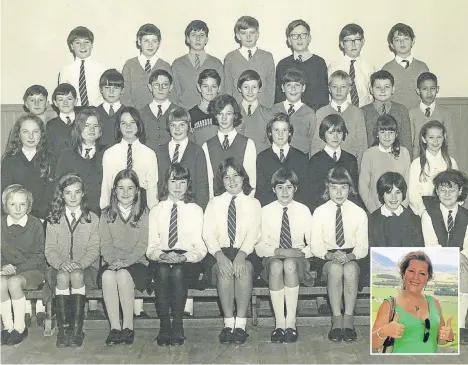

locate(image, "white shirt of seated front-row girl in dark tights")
[[146, 199, 207, 262]]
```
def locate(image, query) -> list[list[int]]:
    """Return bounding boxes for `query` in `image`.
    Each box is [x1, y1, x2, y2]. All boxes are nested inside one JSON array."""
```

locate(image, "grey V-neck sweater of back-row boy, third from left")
[[172, 54, 224, 109]]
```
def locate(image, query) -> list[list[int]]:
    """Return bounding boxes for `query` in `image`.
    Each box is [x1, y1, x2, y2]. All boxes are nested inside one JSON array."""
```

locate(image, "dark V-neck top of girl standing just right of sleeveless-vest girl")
[[255, 147, 310, 207]]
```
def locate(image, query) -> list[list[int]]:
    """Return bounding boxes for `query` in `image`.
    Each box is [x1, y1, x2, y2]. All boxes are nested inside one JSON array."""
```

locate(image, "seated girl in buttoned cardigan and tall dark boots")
[[45, 174, 99, 347]]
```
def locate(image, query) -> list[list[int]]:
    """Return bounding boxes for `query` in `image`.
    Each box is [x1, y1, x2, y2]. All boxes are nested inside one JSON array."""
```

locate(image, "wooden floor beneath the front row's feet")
[[1, 326, 468, 364]]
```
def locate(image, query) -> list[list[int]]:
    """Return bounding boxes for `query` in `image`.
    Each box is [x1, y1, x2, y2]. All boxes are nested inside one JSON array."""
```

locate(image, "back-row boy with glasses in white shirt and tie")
[[328, 24, 375, 108]]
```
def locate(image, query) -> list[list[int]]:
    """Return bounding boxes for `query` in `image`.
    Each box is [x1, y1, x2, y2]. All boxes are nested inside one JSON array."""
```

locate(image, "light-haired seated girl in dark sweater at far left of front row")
[[0, 184, 46, 345]]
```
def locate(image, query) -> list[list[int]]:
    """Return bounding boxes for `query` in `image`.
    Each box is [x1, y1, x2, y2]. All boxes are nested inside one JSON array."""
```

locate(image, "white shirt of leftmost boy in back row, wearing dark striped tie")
[[59, 57, 106, 105]]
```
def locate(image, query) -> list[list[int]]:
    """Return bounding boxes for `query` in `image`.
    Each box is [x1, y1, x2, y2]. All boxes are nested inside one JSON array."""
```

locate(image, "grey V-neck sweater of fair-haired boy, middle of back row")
[[223, 48, 275, 108]]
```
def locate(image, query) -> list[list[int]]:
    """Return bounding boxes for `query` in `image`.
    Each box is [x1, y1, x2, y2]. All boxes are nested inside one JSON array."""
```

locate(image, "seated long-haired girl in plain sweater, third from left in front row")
[[98, 170, 150, 345]]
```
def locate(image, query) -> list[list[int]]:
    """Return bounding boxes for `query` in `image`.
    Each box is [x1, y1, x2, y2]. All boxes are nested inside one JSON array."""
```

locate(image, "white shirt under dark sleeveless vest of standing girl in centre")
[[202, 129, 257, 198]]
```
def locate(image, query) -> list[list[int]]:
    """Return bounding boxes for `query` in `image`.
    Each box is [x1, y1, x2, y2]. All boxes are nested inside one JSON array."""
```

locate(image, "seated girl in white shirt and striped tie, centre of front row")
[[203, 157, 261, 344]]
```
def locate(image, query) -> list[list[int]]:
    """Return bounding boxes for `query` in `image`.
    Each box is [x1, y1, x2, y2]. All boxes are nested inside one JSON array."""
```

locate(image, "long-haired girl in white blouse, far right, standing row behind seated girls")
[[408, 120, 458, 216]]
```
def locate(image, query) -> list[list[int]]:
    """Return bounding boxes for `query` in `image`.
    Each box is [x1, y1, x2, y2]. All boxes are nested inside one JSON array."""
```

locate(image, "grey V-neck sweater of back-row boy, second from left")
[[120, 57, 173, 110]]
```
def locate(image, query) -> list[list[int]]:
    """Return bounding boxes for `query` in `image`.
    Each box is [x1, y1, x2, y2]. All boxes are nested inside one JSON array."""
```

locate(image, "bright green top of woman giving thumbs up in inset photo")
[[389, 295, 440, 354]]
